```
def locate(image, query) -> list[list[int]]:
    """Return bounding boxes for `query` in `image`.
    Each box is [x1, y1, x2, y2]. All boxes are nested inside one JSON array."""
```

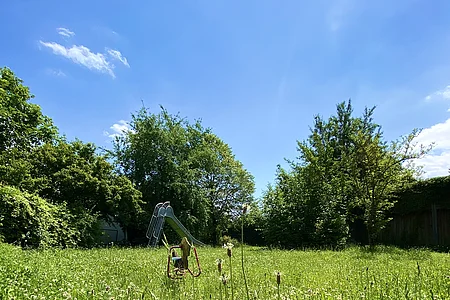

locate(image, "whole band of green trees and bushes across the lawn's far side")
[[0, 68, 442, 247]]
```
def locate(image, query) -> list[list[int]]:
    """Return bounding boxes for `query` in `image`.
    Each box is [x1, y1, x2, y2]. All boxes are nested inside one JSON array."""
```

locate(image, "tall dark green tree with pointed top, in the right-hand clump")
[[291, 101, 357, 246]]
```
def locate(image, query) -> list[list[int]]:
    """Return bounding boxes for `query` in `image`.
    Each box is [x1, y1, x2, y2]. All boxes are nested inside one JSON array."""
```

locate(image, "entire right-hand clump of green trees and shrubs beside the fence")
[[264, 101, 429, 246]]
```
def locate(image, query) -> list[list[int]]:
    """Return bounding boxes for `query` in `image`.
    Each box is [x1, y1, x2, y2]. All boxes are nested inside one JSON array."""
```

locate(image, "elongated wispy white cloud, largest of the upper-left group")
[[39, 41, 116, 78]]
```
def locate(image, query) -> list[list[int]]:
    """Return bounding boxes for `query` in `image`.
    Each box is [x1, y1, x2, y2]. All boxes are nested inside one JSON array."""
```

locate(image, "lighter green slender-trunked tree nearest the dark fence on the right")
[[351, 123, 431, 246]]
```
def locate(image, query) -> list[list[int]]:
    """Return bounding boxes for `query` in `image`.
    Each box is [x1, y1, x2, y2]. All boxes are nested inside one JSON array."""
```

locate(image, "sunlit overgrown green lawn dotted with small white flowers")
[[0, 244, 450, 299]]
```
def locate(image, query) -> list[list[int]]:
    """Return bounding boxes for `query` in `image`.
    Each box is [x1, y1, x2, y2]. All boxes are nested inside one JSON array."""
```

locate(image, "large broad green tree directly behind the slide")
[[114, 108, 254, 242]]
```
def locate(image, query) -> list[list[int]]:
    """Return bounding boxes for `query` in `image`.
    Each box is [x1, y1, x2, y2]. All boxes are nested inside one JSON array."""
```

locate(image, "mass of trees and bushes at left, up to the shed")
[[0, 68, 142, 247]]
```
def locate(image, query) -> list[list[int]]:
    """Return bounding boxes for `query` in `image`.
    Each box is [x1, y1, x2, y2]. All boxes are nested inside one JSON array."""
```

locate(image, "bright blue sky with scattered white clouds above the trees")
[[0, 0, 450, 196]]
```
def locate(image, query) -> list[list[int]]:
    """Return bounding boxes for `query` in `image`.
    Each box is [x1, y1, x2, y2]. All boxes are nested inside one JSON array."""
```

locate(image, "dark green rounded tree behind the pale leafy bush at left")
[[20, 139, 143, 229]]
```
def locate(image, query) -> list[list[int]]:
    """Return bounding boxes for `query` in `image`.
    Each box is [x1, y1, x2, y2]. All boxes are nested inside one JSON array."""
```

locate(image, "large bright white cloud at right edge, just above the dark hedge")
[[414, 118, 450, 178]]
